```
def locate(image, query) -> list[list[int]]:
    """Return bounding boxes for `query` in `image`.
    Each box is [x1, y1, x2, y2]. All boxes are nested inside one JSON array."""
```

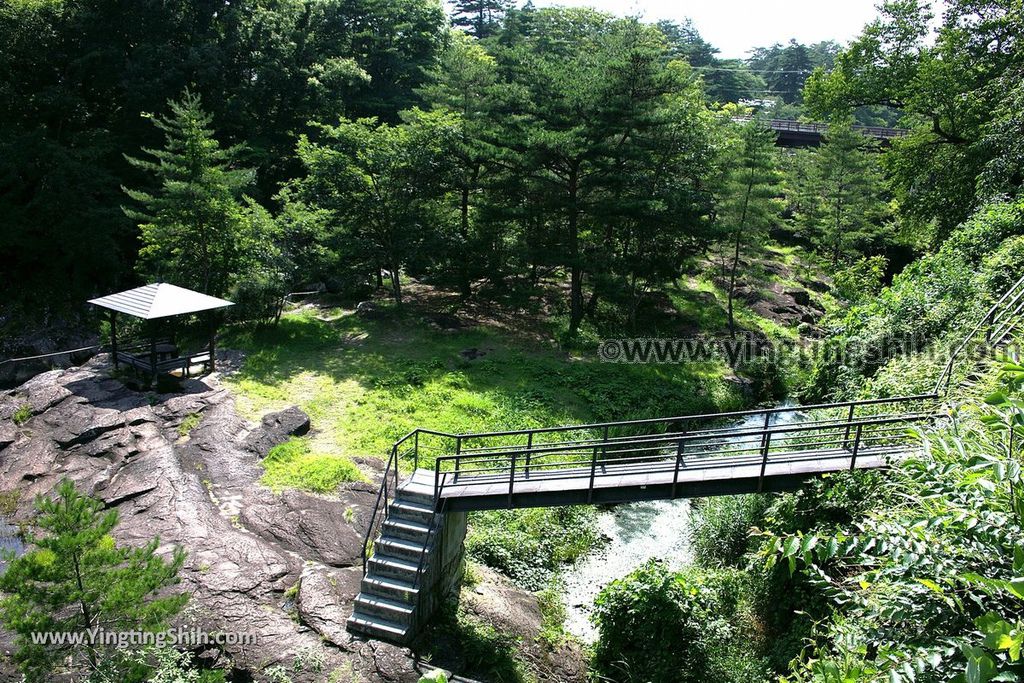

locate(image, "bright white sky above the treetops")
[[534, 0, 879, 58]]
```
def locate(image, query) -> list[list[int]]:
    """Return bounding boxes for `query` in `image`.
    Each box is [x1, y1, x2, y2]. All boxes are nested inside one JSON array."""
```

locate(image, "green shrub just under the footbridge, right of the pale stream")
[[689, 495, 772, 568]]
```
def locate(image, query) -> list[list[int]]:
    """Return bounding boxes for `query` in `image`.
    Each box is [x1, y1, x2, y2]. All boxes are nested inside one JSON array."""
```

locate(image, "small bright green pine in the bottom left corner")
[[0, 479, 187, 682]]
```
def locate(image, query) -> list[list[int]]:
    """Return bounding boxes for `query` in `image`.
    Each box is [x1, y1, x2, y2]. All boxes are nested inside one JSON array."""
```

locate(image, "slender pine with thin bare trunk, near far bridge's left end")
[[719, 119, 780, 337]]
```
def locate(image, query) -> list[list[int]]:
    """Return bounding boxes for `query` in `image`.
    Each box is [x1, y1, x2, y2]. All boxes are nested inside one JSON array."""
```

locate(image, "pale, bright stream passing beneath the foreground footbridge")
[[561, 403, 802, 643]]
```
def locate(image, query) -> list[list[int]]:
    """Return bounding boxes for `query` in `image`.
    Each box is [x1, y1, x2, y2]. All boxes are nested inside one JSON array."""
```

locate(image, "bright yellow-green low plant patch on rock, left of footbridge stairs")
[[260, 438, 362, 494]]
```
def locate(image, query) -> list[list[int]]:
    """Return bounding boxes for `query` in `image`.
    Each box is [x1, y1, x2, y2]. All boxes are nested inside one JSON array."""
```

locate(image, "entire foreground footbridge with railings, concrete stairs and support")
[[348, 394, 938, 642]]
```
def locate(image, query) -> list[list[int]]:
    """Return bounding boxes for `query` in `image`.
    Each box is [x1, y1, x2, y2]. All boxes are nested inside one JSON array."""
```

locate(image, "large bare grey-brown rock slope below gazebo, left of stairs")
[[0, 356, 581, 683]]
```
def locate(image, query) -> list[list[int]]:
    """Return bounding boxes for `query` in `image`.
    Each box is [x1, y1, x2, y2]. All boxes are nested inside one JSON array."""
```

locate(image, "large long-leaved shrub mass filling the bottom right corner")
[[763, 376, 1024, 683]]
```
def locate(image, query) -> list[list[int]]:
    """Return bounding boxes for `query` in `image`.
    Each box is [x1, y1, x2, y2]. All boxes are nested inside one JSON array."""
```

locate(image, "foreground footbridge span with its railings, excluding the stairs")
[[397, 394, 936, 512]]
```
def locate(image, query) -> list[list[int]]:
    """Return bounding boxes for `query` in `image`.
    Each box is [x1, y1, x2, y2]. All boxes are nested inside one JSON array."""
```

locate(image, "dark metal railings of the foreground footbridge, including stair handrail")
[[362, 394, 936, 573]]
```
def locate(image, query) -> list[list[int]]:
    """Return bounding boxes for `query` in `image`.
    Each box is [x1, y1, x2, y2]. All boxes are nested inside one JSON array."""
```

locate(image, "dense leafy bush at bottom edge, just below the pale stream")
[[593, 560, 742, 683]]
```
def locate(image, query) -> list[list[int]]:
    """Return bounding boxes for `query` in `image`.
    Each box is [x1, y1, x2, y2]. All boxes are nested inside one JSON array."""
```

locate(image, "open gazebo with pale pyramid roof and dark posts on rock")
[[89, 283, 234, 382]]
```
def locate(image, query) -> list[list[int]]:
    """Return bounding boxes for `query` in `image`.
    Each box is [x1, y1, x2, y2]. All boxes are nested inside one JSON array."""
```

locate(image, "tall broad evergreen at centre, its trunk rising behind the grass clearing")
[[498, 8, 705, 336]]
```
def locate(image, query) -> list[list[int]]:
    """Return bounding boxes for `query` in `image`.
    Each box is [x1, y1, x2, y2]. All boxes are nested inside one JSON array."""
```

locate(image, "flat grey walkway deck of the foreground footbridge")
[[407, 446, 907, 511]]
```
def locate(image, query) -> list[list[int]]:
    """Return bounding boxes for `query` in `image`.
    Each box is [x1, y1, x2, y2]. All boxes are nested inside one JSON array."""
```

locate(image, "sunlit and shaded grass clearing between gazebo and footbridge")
[[225, 310, 740, 466]]
